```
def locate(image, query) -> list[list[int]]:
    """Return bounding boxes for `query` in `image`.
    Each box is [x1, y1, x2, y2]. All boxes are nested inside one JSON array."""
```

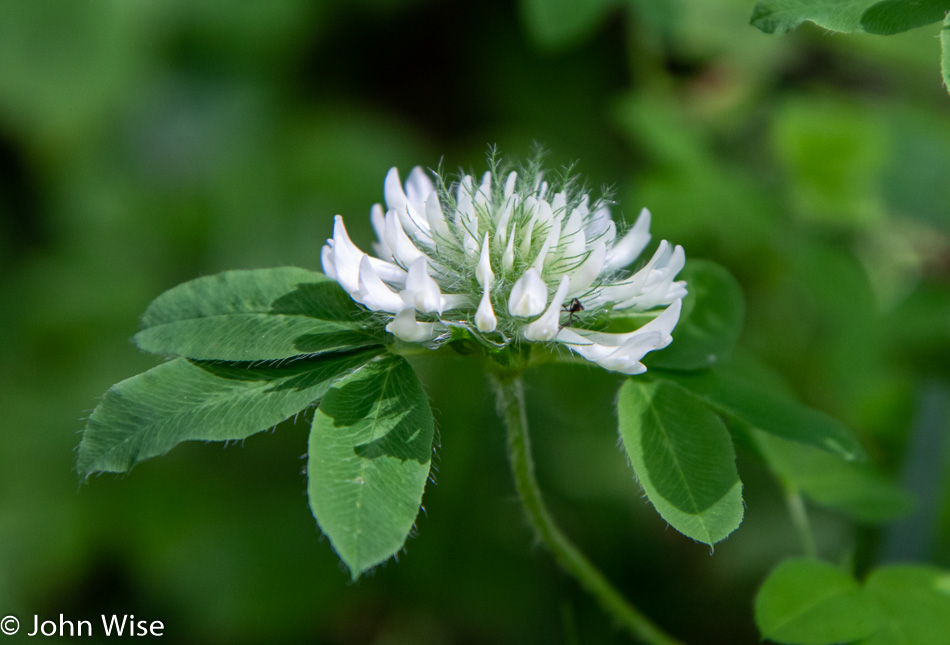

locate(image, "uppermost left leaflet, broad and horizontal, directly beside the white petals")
[[135, 267, 384, 361]]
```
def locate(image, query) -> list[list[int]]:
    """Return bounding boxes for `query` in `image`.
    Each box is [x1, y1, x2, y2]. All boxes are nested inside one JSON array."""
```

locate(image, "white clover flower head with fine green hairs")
[[321, 160, 686, 374]]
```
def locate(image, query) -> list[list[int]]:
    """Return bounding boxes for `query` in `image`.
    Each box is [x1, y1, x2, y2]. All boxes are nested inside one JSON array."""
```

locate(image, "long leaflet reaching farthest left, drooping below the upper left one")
[[78, 349, 380, 475]]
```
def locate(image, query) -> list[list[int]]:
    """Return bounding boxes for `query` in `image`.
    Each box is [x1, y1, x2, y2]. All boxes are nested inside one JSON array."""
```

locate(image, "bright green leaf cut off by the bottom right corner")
[[863, 565, 950, 645]]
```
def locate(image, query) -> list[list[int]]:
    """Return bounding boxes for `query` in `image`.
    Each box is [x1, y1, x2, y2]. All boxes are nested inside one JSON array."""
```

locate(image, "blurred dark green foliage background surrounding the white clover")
[[0, 0, 950, 645]]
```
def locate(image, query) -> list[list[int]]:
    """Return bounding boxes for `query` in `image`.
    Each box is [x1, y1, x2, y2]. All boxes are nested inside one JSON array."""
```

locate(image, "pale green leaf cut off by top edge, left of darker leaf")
[[751, 0, 876, 34]]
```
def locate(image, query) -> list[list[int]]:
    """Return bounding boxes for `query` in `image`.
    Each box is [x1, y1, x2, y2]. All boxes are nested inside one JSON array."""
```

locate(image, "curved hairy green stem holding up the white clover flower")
[[492, 371, 678, 645]]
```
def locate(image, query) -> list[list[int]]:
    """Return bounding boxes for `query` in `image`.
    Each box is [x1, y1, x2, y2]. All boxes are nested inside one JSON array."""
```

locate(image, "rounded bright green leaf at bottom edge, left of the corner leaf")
[[755, 558, 880, 645]]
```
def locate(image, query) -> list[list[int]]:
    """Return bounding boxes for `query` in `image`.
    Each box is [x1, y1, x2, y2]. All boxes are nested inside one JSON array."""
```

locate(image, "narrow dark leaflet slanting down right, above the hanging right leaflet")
[[662, 366, 865, 460]]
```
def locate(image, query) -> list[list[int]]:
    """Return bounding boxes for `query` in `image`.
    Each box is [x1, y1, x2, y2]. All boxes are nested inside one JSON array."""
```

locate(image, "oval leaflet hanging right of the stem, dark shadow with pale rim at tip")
[[617, 379, 743, 544]]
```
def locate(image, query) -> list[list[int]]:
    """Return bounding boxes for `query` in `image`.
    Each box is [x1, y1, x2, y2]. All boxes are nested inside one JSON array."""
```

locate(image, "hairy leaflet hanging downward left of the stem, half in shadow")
[[307, 355, 434, 579]]
